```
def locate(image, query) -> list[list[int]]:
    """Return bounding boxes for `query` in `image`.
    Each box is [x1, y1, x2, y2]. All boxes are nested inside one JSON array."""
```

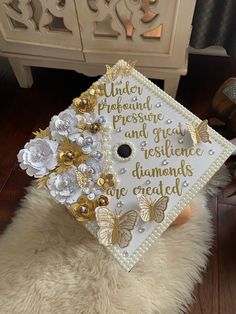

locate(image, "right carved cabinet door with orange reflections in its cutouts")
[[75, 0, 195, 68]]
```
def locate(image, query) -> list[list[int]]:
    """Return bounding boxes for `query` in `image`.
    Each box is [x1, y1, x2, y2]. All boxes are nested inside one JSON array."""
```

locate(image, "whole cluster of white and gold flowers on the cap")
[[18, 82, 116, 223]]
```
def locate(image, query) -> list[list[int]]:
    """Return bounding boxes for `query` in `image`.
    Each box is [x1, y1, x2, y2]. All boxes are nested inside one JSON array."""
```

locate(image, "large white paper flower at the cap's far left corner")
[[17, 137, 58, 178]]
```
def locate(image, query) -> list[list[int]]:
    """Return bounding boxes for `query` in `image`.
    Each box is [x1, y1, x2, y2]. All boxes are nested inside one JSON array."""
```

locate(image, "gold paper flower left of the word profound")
[[73, 92, 97, 114]]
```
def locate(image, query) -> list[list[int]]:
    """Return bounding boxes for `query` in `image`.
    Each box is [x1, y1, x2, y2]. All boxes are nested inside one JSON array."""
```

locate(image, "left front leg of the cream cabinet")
[[8, 58, 33, 88]]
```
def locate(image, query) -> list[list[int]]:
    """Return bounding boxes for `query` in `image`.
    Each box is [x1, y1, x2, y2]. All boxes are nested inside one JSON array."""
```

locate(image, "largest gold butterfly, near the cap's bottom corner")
[[96, 207, 138, 248]]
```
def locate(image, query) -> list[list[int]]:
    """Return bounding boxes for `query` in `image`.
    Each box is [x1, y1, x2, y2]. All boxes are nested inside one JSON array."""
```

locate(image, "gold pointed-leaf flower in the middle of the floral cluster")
[[56, 137, 90, 173]]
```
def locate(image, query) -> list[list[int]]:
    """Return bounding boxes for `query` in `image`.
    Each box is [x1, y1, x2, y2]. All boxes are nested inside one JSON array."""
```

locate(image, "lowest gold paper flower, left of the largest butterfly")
[[69, 195, 96, 223]]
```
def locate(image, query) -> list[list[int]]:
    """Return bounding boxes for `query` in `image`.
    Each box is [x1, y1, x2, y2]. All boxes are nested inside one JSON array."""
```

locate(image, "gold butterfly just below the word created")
[[138, 194, 169, 223]]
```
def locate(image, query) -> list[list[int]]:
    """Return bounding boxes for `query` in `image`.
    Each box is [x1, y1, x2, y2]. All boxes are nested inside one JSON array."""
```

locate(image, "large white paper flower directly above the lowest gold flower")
[[47, 166, 83, 204]]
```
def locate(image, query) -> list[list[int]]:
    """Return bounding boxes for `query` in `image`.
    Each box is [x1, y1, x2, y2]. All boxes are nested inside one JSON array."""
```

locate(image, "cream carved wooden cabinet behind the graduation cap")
[[0, 0, 195, 96]]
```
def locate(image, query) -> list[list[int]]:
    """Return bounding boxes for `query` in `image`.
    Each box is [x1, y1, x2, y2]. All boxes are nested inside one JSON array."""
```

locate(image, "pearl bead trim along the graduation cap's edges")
[[84, 60, 235, 272]]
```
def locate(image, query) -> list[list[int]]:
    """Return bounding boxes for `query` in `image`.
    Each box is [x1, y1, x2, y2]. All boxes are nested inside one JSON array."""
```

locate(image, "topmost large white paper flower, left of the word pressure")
[[49, 109, 82, 141]]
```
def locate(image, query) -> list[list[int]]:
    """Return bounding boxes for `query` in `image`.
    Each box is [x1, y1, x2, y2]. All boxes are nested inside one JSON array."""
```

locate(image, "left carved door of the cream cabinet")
[[0, 0, 84, 60]]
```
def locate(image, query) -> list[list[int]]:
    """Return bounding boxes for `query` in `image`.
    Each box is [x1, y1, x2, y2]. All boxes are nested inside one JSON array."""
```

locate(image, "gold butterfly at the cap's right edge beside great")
[[188, 120, 211, 145]]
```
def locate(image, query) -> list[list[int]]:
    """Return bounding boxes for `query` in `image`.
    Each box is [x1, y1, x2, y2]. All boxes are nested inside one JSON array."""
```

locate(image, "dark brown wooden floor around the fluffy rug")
[[0, 56, 236, 314]]
